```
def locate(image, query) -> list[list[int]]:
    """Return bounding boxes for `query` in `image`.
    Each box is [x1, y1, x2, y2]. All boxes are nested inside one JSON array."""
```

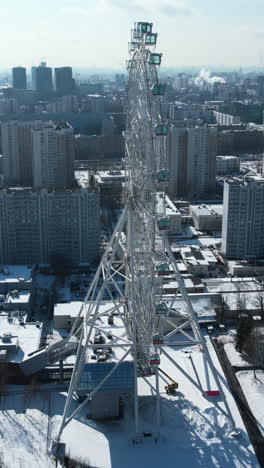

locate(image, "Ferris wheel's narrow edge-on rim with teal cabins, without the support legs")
[[125, 23, 169, 373]]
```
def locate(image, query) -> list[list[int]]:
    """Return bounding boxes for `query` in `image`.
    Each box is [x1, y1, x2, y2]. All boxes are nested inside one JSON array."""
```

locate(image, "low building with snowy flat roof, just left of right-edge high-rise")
[[190, 203, 223, 231]]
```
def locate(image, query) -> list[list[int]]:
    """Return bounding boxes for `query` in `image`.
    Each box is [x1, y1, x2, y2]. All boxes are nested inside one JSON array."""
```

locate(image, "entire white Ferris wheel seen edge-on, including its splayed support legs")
[[54, 22, 235, 446]]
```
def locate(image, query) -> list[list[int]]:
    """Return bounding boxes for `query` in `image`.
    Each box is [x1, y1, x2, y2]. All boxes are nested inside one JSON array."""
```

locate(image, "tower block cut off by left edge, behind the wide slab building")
[[1, 120, 45, 186]]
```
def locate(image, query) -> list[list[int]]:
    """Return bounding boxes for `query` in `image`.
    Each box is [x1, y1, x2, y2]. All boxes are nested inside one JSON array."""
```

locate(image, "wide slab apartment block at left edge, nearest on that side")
[[0, 185, 100, 265]]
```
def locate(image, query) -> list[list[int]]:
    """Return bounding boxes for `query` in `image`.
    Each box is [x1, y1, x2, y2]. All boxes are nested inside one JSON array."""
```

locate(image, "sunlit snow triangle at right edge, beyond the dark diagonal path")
[[236, 371, 264, 435]]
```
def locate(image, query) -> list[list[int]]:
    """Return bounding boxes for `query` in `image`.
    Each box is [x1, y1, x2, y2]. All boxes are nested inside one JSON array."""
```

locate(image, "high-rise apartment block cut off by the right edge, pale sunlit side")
[[222, 176, 264, 259]]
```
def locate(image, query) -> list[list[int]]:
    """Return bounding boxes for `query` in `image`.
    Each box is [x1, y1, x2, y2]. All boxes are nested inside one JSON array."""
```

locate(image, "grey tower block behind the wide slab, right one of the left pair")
[[32, 121, 75, 189]]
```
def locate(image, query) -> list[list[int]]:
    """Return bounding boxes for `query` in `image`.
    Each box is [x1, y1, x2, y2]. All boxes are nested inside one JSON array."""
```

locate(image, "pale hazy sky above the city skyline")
[[0, 0, 264, 69]]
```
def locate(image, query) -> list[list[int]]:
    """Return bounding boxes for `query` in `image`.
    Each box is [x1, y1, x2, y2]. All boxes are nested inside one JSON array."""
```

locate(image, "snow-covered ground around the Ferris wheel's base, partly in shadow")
[[0, 341, 259, 468]]
